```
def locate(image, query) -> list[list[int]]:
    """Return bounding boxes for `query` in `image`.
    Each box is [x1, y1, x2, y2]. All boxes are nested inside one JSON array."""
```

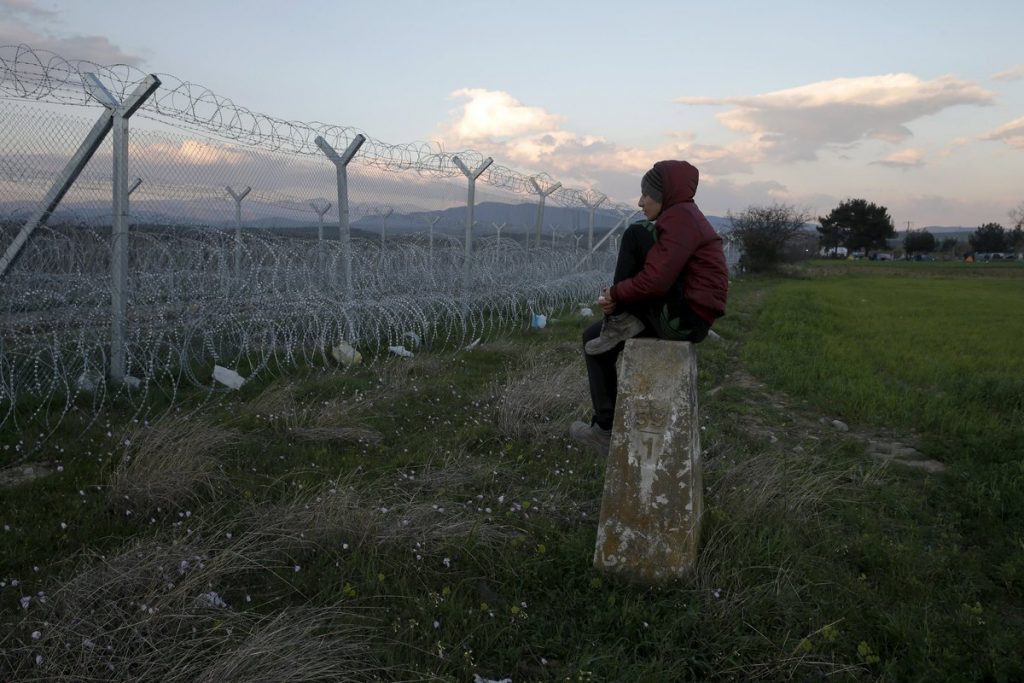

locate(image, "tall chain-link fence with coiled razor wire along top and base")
[[0, 46, 632, 448]]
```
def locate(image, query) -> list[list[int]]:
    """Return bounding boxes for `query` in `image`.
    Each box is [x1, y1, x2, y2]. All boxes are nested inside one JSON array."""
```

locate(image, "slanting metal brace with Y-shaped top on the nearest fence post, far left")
[[0, 74, 160, 278]]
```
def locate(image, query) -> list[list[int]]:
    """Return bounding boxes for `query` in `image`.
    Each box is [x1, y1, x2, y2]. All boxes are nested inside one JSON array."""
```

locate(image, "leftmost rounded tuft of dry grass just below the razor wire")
[[110, 416, 241, 514]]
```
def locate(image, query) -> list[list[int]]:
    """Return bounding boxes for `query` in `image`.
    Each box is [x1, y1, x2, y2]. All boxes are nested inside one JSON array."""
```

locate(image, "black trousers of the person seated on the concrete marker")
[[583, 223, 710, 429]]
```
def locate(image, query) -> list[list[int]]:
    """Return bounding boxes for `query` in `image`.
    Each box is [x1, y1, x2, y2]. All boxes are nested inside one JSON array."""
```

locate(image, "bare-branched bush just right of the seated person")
[[727, 203, 811, 272]]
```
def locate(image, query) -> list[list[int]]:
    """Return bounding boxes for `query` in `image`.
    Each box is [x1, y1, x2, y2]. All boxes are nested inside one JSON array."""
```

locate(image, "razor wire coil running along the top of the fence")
[[0, 44, 625, 208]]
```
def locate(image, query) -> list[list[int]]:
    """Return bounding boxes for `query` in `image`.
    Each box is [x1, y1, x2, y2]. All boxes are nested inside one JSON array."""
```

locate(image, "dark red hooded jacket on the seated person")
[[611, 161, 729, 325]]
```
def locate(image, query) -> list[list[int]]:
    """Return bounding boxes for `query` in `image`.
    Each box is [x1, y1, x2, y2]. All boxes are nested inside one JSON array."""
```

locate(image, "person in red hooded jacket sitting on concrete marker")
[[569, 161, 729, 455]]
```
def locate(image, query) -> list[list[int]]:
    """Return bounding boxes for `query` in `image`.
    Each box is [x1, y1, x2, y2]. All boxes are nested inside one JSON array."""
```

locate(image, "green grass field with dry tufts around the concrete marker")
[[0, 262, 1024, 683]]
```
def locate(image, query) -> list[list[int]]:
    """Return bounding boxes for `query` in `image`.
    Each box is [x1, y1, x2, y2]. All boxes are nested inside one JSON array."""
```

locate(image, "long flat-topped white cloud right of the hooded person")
[[676, 74, 992, 162]]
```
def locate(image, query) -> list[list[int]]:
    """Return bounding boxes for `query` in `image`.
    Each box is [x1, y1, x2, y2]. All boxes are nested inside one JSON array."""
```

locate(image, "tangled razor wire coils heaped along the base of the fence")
[[0, 226, 613, 440]]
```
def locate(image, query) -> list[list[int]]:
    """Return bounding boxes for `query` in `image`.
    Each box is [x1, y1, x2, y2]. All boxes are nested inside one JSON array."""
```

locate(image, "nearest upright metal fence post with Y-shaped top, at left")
[[84, 74, 160, 383]]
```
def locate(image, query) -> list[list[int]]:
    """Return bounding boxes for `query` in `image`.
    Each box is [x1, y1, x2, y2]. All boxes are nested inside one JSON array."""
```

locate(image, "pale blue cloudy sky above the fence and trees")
[[0, 0, 1024, 228]]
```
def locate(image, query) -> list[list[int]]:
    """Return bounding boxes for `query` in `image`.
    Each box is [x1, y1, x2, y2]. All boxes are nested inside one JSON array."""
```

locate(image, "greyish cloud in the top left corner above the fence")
[[0, 0, 142, 66]]
